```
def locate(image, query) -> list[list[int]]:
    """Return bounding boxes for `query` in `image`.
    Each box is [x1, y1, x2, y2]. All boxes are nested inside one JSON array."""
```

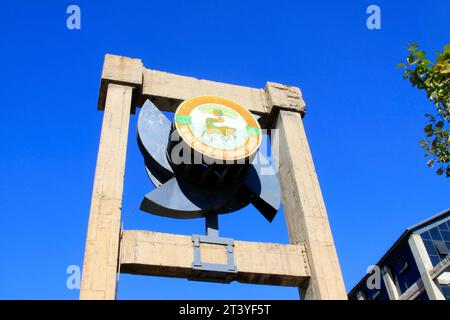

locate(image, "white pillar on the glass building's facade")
[[408, 234, 445, 300]]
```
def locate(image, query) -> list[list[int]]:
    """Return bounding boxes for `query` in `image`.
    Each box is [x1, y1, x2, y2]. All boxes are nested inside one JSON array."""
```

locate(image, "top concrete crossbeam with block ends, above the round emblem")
[[98, 54, 305, 128]]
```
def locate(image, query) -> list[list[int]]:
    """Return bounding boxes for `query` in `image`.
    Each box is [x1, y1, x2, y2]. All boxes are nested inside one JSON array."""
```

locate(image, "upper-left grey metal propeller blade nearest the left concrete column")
[[137, 100, 174, 187]]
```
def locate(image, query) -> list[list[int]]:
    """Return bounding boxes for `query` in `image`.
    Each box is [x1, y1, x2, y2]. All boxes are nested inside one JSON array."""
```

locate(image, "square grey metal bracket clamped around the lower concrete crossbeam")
[[189, 234, 237, 283]]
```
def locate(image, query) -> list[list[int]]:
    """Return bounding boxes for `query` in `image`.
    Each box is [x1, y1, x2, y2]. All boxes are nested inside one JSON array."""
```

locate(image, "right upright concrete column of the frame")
[[272, 110, 347, 300]]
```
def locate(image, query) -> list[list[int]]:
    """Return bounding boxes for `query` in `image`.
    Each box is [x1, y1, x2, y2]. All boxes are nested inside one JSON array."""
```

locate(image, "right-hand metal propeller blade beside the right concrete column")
[[244, 153, 281, 222]]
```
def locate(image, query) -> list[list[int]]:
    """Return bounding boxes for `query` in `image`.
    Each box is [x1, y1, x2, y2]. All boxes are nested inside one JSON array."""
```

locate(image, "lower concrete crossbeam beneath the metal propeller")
[[120, 230, 310, 286]]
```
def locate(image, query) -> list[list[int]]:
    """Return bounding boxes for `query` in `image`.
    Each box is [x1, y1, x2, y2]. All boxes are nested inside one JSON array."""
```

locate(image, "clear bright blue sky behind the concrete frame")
[[0, 0, 450, 299]]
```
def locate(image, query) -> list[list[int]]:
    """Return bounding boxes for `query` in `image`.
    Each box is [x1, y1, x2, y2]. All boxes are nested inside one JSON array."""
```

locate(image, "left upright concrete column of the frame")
[[80, 84, 133, 299]]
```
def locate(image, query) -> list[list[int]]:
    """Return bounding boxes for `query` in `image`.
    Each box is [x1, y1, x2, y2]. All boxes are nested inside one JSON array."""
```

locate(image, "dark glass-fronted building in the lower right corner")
[[348, 210, 450, 300]]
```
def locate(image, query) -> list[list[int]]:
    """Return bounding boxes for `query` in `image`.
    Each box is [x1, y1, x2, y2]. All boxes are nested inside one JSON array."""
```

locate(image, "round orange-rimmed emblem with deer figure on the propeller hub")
[[175, 96, 261, 160]]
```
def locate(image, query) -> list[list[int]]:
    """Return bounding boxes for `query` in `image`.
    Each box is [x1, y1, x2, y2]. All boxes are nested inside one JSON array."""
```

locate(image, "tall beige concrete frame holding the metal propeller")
[[80, 54, 347, 299]]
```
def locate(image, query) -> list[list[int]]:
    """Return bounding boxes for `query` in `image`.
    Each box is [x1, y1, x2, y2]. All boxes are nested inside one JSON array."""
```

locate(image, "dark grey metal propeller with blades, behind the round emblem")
[[137, 100, 280, 221]]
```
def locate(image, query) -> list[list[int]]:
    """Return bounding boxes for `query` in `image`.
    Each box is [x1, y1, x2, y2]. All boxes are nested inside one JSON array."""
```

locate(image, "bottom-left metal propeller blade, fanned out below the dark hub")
[[141, 177, 244, 219]]
